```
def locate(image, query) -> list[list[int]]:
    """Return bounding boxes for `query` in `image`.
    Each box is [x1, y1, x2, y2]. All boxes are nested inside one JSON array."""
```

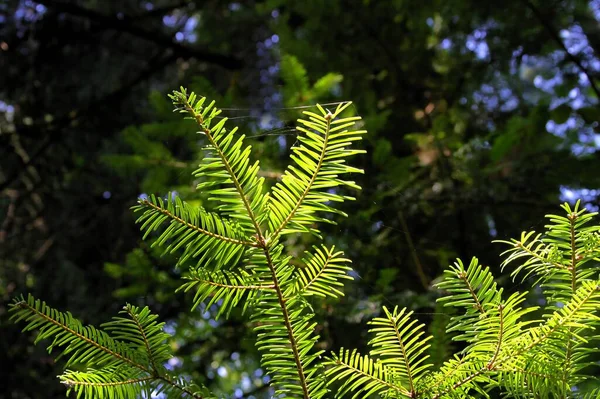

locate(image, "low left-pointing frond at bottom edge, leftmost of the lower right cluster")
[[325, 348, 412, 399]]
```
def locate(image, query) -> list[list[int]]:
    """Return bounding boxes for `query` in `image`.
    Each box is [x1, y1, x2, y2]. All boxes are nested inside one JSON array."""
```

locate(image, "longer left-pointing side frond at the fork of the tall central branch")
[[133, 193, 256, 269]]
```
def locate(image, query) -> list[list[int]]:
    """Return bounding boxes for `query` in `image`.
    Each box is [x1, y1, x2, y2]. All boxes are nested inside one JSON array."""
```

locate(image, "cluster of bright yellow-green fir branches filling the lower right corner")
[[328, 203, 600, 399]]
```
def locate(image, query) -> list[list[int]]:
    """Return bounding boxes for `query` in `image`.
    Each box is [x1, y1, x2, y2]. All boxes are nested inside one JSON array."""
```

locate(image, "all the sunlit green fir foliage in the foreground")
[[12, 89, 600, 399]]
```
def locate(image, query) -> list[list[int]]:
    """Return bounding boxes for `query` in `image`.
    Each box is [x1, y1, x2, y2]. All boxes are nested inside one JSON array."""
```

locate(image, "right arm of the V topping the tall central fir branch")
[[268, 102, 366, 239]]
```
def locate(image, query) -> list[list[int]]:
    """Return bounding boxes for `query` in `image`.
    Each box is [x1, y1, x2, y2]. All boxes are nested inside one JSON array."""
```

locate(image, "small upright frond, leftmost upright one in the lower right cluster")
[[369, 306, 431, 396]]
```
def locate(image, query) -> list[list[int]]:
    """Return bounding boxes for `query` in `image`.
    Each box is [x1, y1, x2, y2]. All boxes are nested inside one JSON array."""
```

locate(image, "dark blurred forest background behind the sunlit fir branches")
[[0, 0, 600, 398]]
